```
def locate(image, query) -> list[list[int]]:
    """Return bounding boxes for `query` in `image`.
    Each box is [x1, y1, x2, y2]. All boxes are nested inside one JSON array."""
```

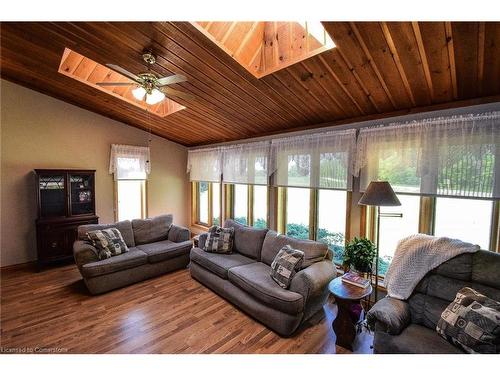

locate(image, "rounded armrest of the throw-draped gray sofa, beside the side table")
[[366, 297, 411, 335]]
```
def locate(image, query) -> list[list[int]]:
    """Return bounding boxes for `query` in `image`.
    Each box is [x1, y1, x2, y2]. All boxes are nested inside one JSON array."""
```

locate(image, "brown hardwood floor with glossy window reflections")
[[0, 265, 371, 353]]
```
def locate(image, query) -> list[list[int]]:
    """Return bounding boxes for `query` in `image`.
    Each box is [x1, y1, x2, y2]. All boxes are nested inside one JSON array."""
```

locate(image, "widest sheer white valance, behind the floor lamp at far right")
[[355, 112, 500, 198]]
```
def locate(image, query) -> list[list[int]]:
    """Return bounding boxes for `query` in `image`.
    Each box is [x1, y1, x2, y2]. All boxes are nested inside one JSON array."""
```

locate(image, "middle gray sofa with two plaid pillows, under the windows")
[[189, 220, 336, 336]]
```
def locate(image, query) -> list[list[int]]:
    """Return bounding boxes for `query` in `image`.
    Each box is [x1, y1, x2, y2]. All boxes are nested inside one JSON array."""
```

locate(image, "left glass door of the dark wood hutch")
[[39, 173, 66, 217]]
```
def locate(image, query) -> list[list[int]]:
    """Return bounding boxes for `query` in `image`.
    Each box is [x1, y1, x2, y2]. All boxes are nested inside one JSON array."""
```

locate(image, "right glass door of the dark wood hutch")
[[69, 173, 94, 215]]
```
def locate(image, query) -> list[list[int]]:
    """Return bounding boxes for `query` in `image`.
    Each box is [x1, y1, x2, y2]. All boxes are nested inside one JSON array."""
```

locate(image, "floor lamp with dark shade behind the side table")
[[358, 181, 403, 303]]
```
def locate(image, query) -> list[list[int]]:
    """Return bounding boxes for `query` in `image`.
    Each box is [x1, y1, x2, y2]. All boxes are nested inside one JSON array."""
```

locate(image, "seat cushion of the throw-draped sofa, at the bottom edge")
[[373, 324, 463, 354]]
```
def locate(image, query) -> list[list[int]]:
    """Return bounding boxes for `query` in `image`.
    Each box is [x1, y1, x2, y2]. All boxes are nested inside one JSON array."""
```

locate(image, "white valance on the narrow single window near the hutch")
[[109, 144, 151, 180]]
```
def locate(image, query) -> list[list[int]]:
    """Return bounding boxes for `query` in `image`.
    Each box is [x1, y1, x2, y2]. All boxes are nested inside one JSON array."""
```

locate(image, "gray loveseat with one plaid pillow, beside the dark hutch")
[[73, 215, 193, 294]]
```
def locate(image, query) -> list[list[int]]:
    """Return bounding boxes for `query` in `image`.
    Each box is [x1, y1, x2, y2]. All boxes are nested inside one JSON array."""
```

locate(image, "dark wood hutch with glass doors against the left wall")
[[35, 169, 99, 269]]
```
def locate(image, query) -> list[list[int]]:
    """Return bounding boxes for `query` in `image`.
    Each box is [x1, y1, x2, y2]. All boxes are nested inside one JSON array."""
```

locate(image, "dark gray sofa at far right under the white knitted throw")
[[367, 250, 500, 354]]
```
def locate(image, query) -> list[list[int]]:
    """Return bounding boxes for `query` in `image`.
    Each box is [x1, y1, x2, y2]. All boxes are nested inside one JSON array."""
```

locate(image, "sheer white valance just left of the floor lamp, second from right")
[[270, 129, 356, 190]]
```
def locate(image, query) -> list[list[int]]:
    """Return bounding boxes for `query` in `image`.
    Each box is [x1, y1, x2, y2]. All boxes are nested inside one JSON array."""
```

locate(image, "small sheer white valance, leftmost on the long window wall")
[[187, 147, 222, 182]]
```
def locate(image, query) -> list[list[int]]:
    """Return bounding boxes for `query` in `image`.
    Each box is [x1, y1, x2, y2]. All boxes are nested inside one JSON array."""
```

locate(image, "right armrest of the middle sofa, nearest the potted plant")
[[290, 260, 337, 303]]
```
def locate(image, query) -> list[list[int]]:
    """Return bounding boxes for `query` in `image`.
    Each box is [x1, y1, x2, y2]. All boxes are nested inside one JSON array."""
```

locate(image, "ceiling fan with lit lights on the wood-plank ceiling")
[[97, 51, 193, 105]]
